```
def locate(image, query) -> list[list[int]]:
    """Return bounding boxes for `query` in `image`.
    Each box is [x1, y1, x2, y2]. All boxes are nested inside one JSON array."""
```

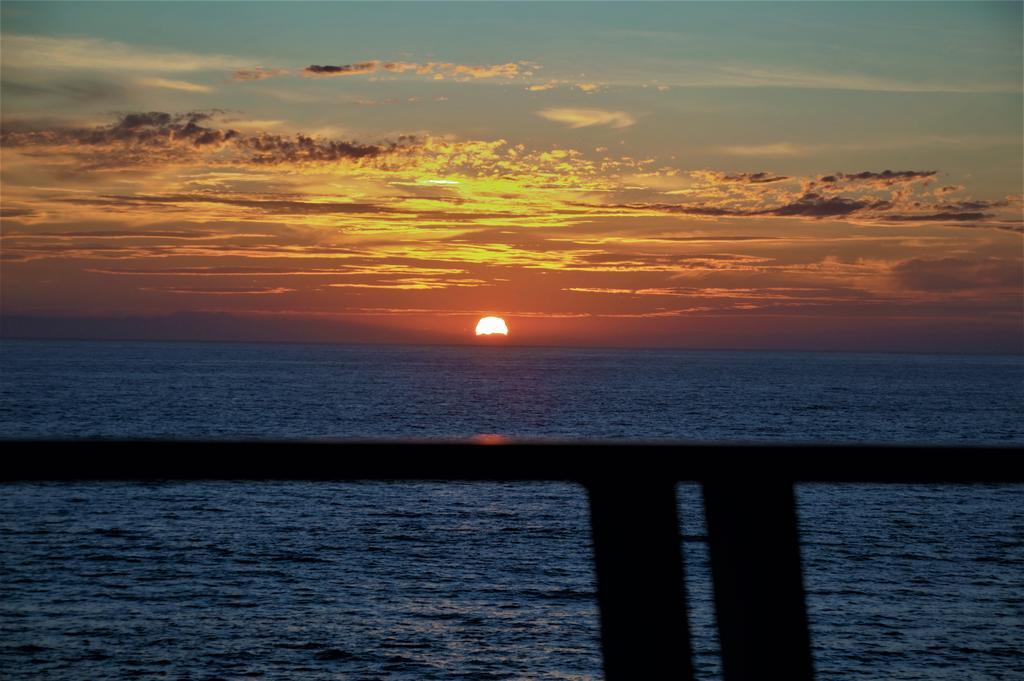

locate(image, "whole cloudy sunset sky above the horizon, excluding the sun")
[[0, 2, 1024, 352]]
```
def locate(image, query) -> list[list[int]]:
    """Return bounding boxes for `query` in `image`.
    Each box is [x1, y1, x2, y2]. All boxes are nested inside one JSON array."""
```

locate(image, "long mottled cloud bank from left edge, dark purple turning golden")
[[0, 111, 647, 193]]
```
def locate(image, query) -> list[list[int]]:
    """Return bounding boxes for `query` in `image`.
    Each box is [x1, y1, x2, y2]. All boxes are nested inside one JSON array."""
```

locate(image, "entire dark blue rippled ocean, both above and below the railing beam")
[[0, 341, 1024, 681]]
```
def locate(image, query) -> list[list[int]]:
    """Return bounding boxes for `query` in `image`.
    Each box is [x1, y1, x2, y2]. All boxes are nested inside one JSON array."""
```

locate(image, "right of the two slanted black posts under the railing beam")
[[703, 478, 814, 681]]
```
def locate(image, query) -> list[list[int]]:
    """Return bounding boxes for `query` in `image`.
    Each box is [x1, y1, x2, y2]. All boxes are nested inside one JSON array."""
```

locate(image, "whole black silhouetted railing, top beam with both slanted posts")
[[0, 441, 1024, 681]]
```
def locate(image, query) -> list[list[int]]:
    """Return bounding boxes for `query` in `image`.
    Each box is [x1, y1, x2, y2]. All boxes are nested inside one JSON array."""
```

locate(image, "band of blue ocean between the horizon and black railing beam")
[[0, 340, 1024, 444]]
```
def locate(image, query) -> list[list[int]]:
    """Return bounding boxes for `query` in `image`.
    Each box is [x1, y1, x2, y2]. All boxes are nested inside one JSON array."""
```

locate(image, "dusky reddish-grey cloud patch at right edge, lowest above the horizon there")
[[892, 258, 1024, 292]]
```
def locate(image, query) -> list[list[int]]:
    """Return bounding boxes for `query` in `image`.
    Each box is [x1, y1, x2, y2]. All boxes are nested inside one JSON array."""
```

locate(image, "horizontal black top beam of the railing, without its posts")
[[0, 440, 1024, 483]]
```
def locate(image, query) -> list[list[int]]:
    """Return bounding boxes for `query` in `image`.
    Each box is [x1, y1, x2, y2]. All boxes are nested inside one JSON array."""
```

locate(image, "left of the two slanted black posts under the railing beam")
[[587, 477, 693, 681]]
